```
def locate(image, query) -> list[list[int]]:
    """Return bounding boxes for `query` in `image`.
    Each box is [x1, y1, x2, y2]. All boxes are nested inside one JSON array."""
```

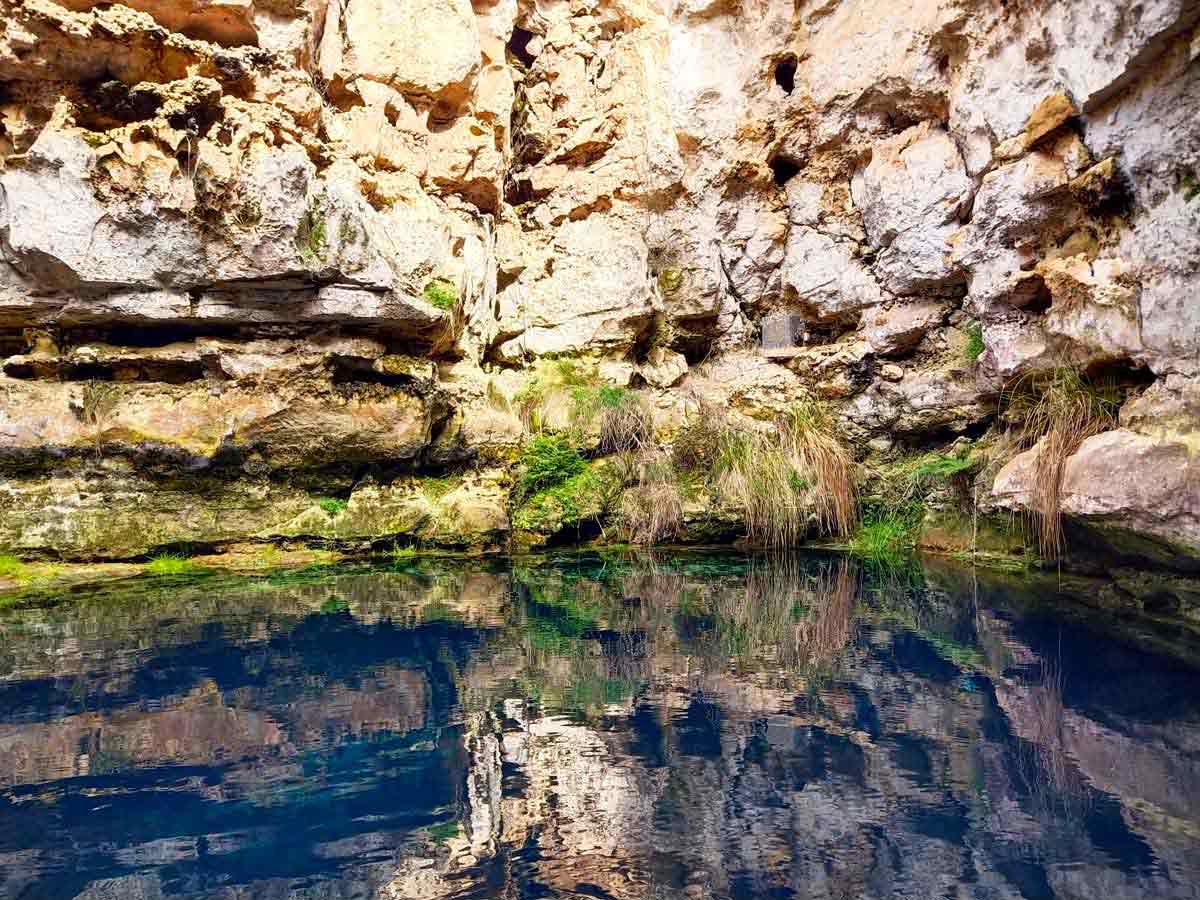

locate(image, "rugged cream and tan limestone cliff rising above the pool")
[[0, 0, 1200, 564]]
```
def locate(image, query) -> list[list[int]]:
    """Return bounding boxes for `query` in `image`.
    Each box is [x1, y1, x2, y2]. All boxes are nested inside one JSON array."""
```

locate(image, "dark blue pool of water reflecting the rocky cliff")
[[0, 554, 1200, 900]]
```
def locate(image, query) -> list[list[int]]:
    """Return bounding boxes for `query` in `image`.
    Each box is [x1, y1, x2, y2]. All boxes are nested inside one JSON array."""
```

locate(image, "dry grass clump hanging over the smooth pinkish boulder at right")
[[1008, 367, 1120, 559]]
